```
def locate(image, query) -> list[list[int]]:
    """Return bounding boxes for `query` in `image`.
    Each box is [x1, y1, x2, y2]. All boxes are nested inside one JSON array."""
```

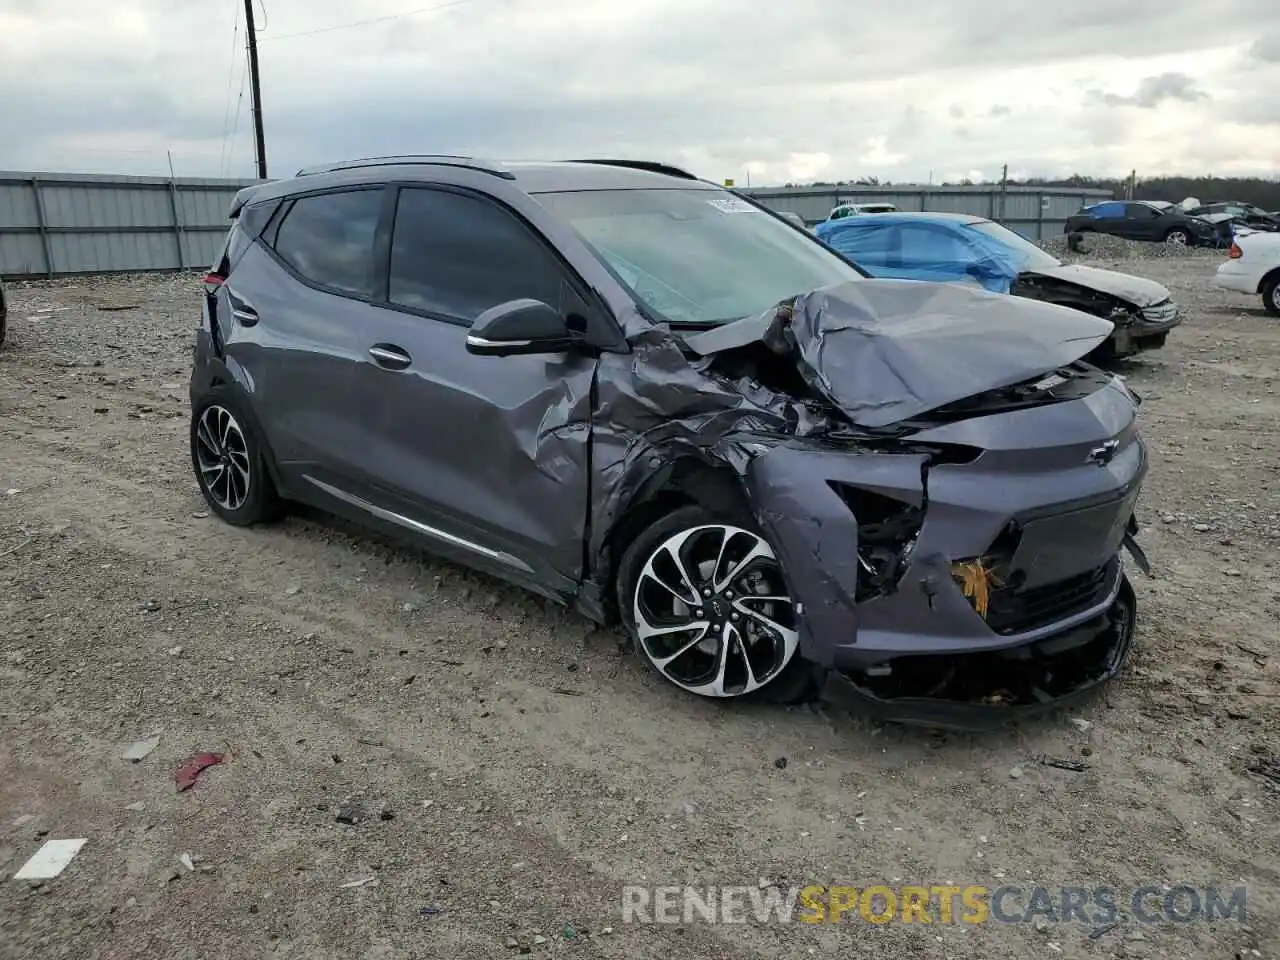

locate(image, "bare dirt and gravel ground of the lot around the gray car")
[[0, 255, 1280, 960]]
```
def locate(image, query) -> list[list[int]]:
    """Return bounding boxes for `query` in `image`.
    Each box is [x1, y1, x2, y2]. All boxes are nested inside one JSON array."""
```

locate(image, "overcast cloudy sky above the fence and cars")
[[0, 0, 1280, 184]]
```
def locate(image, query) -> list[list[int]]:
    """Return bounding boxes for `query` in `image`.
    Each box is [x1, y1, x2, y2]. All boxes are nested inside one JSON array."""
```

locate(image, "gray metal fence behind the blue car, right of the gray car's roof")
[[740, 183, 1112, 241]]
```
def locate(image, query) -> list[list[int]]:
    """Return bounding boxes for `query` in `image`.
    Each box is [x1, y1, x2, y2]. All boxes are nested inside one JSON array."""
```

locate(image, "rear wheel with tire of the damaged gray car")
[[191, 387, 280, 526]]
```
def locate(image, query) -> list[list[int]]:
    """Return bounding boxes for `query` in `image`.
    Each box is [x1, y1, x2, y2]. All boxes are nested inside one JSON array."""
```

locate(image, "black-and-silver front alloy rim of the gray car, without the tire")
[[632, 524, 800, 698]]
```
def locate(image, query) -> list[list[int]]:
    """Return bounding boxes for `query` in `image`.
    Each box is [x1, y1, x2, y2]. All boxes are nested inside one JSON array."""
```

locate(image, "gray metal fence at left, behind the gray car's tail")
[[0, 173, 252, 278]]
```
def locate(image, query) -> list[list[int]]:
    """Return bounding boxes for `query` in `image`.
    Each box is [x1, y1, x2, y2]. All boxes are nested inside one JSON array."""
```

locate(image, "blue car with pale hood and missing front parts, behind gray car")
[[814, 212, 1181, 356]]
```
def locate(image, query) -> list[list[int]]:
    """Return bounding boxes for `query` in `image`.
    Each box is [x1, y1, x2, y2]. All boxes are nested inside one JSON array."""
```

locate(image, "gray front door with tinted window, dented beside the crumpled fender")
[[340, 184, 596, 591]]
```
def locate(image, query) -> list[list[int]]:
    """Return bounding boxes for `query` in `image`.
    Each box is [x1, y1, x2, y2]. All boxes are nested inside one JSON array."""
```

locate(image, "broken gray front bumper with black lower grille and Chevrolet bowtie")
[[748, 364, 1147, 728]]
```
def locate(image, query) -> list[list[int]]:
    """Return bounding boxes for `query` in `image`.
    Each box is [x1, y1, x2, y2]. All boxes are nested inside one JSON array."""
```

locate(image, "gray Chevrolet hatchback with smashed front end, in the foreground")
[[191, 157, 1147, 726]]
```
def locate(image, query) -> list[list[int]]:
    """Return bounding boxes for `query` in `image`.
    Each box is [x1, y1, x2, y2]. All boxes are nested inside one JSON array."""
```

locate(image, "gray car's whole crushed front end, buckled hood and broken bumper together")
[[609, 280, 1147, 727]]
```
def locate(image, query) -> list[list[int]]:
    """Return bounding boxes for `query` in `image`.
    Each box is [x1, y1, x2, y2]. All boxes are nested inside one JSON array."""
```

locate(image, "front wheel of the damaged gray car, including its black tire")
[[617, 506, 817, 703]]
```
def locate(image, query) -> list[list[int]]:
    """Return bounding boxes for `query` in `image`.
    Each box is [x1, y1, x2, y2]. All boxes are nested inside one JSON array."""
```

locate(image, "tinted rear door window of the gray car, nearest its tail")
[[275, 189, 383, 297]]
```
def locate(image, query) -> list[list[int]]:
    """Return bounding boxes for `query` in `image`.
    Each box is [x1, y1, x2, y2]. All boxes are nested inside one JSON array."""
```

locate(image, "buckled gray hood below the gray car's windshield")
[[685, 280, 1114, 429]]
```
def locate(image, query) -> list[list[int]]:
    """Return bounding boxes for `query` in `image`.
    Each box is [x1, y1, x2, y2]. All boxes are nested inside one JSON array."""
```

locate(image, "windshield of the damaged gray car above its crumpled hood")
[[538, 189, 863, 325]]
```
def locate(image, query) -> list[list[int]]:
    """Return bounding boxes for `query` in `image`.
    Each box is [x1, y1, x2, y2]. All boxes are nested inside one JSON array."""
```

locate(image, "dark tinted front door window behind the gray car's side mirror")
[[388, 187, 563, 323]]
